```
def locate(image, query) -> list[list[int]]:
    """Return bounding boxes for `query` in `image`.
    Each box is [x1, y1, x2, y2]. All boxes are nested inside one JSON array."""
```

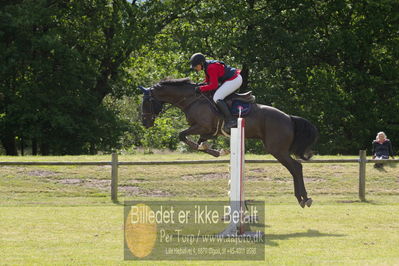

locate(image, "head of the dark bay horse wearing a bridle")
[[139, 86, 163, 128]]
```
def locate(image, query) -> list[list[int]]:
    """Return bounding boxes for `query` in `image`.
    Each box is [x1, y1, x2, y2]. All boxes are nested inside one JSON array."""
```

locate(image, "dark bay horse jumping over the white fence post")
[[140, 78, 318, 208]]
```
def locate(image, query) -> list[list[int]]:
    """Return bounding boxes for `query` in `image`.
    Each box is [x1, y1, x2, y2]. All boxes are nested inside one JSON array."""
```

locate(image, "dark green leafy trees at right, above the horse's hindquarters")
[[150, 0, 399, 154]]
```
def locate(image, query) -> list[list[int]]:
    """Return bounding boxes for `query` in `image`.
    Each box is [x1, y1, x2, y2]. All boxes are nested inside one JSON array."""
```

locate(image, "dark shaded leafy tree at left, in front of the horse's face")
[[0, 0, 194, 155]]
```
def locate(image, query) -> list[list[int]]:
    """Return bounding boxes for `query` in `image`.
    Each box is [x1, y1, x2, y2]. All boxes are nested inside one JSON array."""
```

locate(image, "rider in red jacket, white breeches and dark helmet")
[[190, 53, 242, 132]]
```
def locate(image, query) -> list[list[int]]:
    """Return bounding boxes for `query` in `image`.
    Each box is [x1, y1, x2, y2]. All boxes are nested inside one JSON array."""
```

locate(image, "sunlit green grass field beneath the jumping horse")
[[0, 154, 399, 265]]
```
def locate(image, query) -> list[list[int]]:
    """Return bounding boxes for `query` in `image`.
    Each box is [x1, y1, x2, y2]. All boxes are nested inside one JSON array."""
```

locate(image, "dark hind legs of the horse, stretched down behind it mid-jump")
[[273, 153, 312, 208]]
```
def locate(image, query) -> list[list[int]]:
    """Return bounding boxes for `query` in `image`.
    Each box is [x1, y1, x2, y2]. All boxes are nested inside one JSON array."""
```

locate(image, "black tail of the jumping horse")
[[290, 116, 319, 161]]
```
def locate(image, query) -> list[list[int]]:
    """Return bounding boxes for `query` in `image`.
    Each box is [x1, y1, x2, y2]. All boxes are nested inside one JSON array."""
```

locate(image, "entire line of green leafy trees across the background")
[[0, 0, 399, 155]]
